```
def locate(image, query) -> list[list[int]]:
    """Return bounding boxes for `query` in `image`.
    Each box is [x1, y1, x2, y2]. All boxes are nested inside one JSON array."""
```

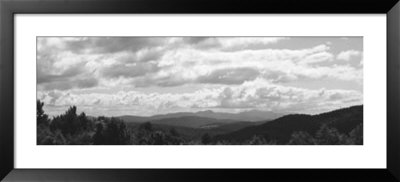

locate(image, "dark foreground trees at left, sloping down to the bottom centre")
[[37, 100, 186, 145]]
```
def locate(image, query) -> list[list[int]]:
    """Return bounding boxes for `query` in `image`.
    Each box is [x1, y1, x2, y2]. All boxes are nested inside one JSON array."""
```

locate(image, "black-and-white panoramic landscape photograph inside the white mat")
[[36, 36, 363, 145]]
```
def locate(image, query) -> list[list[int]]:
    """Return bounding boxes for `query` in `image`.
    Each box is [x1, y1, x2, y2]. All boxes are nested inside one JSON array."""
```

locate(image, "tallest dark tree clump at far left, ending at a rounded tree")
[[37, 101, 131, 145]]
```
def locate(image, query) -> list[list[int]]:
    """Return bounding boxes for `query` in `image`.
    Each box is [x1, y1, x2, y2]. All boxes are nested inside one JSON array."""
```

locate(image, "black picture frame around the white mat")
[[0, 0, 400, 181]]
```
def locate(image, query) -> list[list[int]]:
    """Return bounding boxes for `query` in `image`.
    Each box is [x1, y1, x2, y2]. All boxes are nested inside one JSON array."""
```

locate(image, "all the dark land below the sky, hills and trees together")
[[37, 100, 363, 145]]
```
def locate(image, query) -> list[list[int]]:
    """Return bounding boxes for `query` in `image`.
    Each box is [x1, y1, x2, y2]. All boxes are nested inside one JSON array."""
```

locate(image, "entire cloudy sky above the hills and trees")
[[37, 37, 363, 116]]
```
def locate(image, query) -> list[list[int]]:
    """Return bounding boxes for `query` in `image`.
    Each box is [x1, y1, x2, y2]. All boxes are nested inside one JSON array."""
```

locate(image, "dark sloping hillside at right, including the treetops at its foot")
[[216, 106, 363, 144]]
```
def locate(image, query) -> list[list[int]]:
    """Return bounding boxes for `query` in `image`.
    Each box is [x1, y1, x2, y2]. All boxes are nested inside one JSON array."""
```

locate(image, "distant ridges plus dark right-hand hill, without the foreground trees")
[[120, 105, 363, 144]]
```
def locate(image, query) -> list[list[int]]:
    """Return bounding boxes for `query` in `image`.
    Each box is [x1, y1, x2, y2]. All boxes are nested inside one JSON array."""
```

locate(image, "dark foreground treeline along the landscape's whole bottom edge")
[[37, 100, 363, 145]]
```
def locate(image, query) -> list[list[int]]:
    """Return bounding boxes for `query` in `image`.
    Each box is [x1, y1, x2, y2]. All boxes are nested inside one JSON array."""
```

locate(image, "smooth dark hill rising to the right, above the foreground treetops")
[[215, 105, 363, 144]]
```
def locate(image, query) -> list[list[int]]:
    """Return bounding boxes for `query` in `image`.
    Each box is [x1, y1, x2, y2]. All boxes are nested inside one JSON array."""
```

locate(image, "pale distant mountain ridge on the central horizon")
[[119, 110, 285, 122]]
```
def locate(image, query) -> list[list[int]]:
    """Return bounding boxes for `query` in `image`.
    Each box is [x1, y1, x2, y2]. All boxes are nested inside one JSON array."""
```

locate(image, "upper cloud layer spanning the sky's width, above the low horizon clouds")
[[38, 37, 362, 90]]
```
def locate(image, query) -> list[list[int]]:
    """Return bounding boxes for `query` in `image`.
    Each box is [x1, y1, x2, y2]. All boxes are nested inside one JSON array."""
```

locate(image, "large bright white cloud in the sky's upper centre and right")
[[133, 45, 362, 87]]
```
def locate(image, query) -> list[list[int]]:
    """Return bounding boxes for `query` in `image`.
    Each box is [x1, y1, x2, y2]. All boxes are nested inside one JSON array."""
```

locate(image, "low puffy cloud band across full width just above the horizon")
[[38, 79, 362, 115]]
